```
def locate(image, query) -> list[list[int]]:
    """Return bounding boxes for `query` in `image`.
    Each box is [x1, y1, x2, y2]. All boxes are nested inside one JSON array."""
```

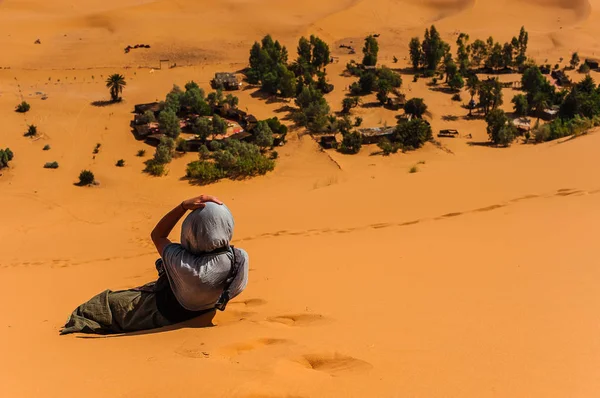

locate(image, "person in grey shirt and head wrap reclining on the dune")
[[60, 195, 249, 334]]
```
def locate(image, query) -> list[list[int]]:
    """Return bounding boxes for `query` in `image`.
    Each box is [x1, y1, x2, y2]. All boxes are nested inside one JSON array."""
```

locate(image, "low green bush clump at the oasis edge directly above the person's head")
[[186, 139, 275, 184]]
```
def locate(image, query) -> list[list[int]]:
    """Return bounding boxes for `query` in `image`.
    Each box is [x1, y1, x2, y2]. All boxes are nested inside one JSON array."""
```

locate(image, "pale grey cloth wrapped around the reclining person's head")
[[181, 202, 234, 255]]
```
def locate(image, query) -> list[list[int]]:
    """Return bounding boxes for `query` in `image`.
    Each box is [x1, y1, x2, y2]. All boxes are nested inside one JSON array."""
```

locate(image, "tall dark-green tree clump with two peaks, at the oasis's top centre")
[[246, 35, 333, 98]]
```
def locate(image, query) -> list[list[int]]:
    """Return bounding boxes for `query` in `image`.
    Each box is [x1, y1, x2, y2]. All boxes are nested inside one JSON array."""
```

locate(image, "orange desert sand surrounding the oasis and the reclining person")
[[0, 0, 600, 398]]
